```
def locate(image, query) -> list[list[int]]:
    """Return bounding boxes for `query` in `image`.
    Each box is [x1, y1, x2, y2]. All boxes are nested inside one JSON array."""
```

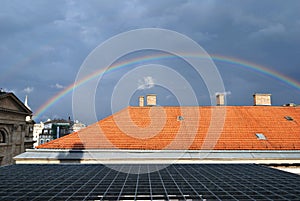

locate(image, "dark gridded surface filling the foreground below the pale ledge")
[[0, 164, 300, 201]]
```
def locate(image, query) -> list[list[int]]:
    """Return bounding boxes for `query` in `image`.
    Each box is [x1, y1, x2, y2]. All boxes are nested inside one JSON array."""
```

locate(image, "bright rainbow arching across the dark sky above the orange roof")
[[34, 53, 300, 119]]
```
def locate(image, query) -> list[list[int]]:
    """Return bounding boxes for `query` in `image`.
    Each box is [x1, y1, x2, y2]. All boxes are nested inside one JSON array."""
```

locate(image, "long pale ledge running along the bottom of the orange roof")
[[14, 149, 300, 164]]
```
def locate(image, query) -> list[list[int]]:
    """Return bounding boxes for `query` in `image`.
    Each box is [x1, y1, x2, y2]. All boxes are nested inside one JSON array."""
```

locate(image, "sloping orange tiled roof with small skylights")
[[37, 106, 300, 150]]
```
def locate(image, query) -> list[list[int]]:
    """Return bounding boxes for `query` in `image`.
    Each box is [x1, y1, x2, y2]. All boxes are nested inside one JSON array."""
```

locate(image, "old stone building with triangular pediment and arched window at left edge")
[[0, 90, 34, 165]]
